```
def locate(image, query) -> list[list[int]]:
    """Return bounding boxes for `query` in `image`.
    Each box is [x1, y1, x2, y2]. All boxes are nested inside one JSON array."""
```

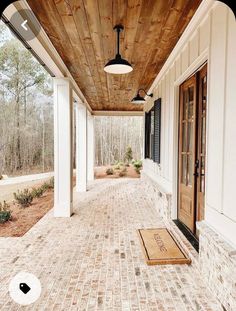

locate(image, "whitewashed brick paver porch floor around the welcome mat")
[[0, 179, 222, 311]]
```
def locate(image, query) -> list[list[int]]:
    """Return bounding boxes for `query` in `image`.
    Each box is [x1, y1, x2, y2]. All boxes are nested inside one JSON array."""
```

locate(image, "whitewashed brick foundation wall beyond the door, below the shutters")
[[141, 172, 172, 220]]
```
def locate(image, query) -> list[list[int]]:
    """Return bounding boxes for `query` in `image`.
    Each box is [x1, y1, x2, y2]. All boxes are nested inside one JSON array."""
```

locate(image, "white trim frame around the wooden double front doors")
[[171, 48, 211, 224]]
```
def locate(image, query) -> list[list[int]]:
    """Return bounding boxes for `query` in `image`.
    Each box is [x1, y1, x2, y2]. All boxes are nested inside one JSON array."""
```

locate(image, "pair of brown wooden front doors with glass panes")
[[178, 66, 207, 234]]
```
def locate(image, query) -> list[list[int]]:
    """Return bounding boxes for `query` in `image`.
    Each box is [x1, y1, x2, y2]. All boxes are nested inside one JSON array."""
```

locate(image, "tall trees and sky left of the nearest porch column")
[[0, 23, 53, 175]]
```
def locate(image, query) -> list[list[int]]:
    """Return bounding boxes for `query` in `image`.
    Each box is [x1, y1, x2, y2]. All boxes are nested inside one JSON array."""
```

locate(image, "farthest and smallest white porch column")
[[87, 112, 95, 181]]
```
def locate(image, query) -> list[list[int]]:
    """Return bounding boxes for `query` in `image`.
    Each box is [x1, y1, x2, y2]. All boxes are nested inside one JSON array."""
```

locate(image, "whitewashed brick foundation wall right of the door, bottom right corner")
[[197, 221, 236, 311]]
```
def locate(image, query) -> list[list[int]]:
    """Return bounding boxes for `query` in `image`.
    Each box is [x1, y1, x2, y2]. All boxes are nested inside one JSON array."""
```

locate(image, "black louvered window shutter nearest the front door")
[[153, 98, 161, 164]]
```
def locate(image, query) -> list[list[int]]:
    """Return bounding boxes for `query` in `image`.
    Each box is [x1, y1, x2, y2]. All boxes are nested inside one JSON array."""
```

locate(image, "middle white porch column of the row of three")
[[76, 103, 87, 192]]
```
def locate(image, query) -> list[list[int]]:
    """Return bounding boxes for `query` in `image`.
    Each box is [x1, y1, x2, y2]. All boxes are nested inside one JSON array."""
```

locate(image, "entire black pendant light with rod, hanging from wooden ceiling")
[[104, 25, 133, 75]]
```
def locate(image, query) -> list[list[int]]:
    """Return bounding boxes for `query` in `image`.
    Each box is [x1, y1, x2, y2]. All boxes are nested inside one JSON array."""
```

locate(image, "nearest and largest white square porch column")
[[54, 78, 73, 217]]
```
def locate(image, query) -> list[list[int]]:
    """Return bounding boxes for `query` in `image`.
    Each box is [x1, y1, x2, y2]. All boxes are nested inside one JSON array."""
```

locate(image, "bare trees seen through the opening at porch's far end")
[[95, 116, 143, 166]]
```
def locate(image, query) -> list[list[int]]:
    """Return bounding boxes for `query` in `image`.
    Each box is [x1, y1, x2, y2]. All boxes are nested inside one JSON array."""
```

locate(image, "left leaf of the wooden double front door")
[[178, 76, 196, 231]]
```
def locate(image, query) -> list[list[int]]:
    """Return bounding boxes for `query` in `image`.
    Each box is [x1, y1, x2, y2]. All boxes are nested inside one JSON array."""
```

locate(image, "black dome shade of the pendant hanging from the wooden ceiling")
[[104, 54, 133, 75]]
